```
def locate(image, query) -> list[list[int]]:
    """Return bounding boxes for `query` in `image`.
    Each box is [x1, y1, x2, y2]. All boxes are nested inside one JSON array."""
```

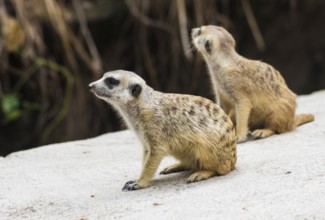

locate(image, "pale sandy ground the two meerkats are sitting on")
[[0, 91, 325, 219]]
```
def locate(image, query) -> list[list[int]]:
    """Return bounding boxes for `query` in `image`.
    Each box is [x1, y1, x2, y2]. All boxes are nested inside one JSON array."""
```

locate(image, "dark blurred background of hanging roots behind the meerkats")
[[0, 0, 325, 156]]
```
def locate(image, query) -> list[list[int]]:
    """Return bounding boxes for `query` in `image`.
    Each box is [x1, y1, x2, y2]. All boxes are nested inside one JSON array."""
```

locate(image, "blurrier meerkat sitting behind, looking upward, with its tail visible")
[[192, 25, 314, 142]]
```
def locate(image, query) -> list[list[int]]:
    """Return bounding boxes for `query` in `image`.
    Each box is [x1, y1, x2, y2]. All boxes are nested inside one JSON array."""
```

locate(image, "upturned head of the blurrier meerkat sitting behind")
[[192, 25, 235, 58]]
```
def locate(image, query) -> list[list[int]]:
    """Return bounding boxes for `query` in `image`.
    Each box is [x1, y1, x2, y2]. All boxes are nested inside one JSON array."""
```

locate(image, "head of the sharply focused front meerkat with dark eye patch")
[[89, 70, 146, 106]]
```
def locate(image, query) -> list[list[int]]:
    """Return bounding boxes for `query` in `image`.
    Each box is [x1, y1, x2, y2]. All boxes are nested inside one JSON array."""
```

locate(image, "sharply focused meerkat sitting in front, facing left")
[[89, 70, 237, 191]]
